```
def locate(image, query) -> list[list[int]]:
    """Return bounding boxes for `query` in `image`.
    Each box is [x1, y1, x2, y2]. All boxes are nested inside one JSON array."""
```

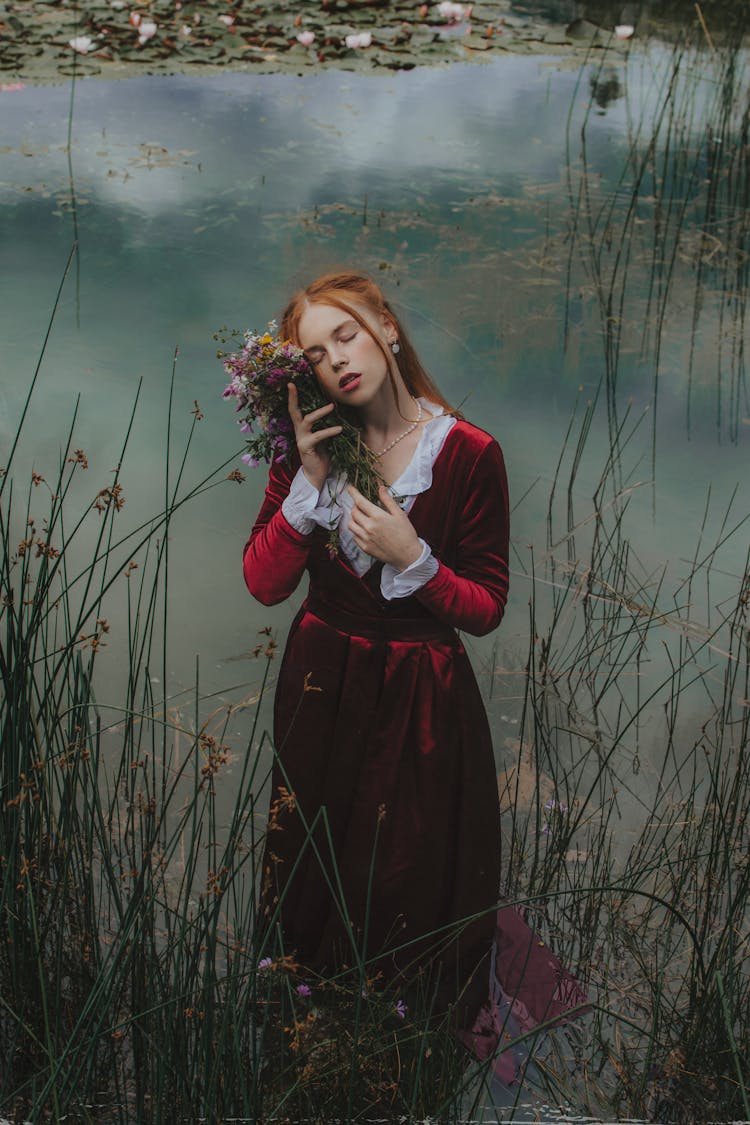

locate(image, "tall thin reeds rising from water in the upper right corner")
[[564, 18, 750, 475]]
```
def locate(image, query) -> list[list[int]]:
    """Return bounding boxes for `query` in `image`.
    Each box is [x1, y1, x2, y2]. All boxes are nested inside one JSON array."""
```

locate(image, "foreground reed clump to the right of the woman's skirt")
[[492, 384, 750, 1122]]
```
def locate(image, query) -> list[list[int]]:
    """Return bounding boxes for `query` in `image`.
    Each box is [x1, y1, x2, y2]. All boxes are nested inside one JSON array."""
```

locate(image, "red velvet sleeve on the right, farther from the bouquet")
[[414, 441, 509, 637]]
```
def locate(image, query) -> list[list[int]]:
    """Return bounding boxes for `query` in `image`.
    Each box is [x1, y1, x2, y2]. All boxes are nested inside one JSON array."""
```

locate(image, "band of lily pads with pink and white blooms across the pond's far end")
[[0, 0, 742, 87]]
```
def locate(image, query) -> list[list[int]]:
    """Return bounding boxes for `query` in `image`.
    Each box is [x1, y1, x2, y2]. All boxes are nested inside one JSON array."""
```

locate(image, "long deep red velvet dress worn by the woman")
[[244, 421, 589, 1037]]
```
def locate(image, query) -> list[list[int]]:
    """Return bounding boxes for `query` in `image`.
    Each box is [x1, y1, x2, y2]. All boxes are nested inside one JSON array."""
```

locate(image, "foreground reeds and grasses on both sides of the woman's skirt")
[[0, 364, 750, 1122]]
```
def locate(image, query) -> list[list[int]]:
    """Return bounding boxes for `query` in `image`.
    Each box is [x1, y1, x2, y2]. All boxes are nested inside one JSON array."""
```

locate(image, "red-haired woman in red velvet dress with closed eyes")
[[244, 273, 580, 1027]]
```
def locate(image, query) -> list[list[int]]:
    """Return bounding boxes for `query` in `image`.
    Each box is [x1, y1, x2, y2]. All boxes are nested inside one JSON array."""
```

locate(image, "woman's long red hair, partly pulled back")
[[280, 272, 457, 414]]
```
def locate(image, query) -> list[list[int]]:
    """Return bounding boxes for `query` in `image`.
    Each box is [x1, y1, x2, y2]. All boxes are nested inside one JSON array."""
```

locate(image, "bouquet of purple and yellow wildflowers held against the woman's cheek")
[[219, 321, 382, 504]]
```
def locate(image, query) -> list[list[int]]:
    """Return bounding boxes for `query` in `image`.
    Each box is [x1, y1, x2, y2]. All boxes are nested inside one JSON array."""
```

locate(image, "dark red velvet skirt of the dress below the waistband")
[[264, 596, 500, 1000]]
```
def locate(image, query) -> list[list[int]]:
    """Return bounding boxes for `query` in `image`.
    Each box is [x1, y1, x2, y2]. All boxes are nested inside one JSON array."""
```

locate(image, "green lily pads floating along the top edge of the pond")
[[0, 0, 750, 82]]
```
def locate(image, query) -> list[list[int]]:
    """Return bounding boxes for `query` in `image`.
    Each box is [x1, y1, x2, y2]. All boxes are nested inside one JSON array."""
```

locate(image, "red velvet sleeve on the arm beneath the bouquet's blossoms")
[[243, 464, 313, 605]]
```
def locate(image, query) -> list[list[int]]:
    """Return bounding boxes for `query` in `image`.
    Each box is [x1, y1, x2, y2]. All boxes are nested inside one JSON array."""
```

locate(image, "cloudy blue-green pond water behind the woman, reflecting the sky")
[[0, 48, 750, 796]]
